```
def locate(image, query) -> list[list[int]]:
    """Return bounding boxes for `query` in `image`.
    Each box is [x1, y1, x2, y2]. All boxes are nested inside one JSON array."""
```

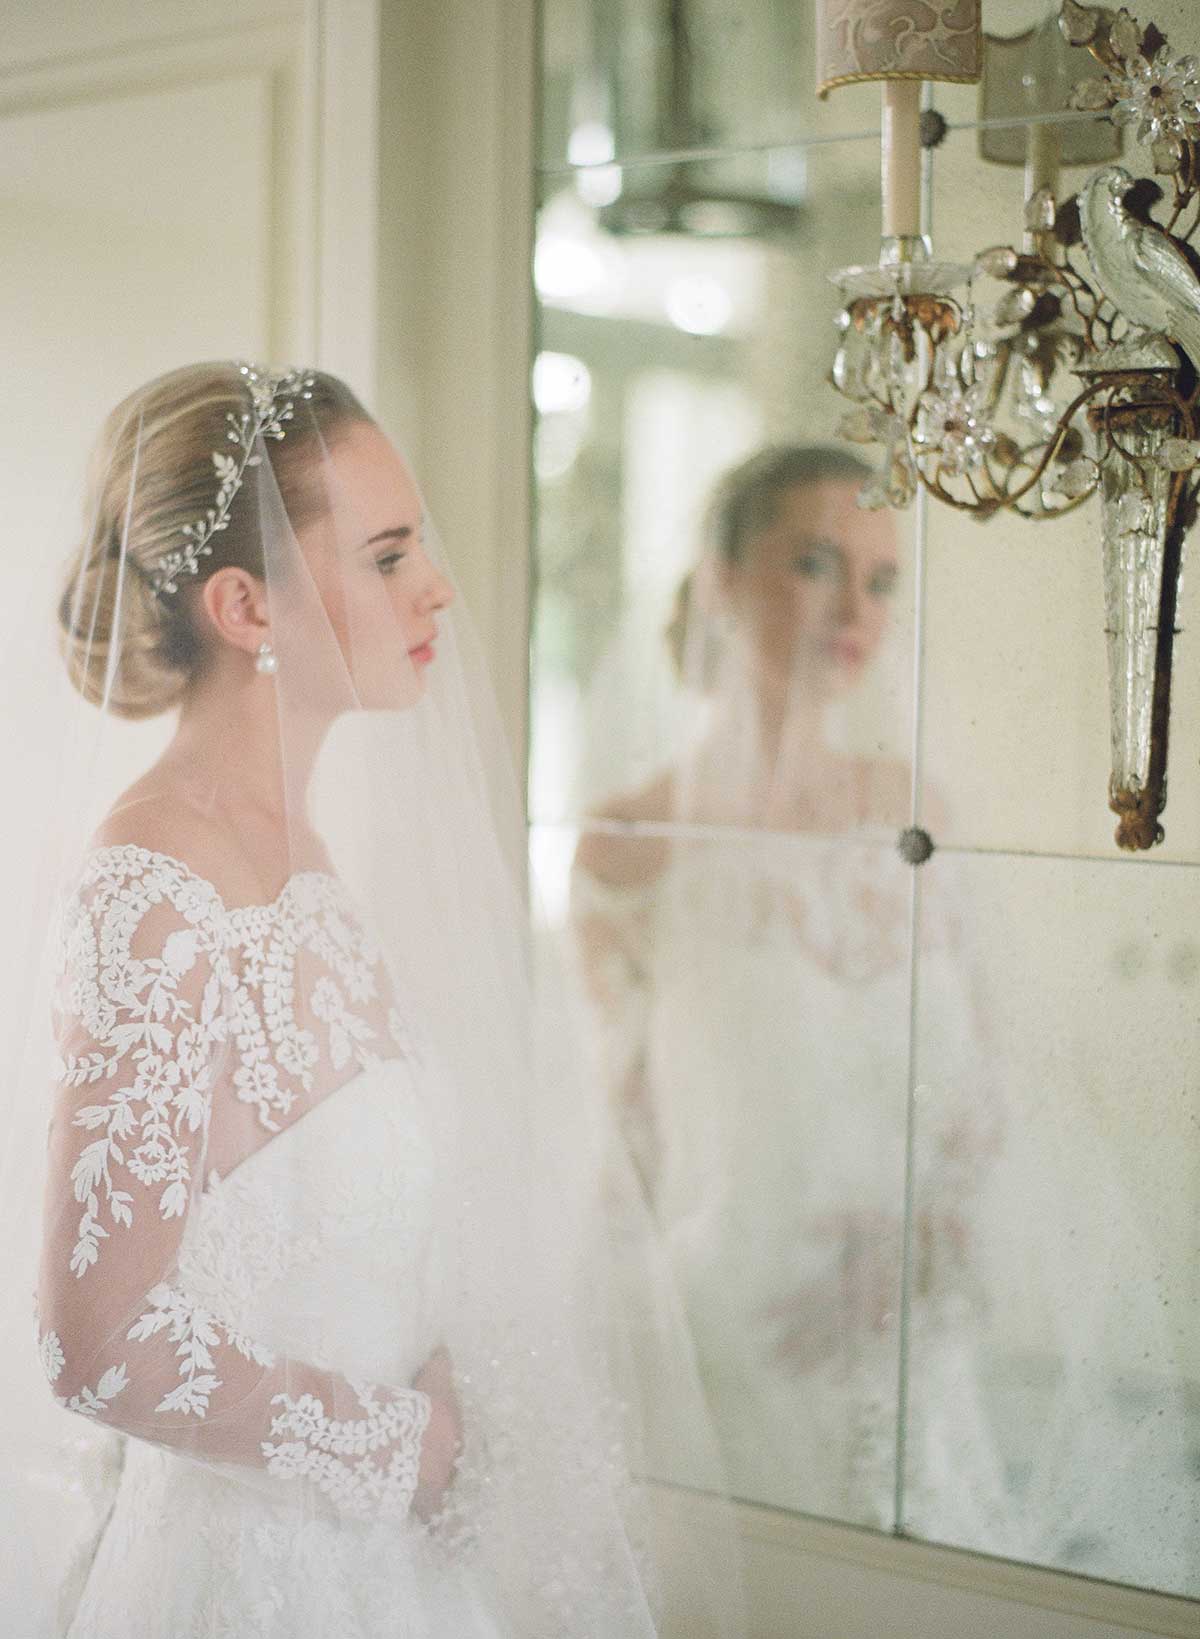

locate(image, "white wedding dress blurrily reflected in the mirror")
[[570, 828, 1020, 1550]]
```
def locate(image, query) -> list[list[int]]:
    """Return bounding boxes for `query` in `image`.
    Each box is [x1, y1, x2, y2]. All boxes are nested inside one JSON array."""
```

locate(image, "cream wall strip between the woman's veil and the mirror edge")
[[379, 0, 536, 770]]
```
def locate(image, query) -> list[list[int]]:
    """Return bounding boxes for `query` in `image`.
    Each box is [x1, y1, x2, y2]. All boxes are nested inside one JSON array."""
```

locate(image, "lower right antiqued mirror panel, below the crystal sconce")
[[903, 852, 1200, 1596]]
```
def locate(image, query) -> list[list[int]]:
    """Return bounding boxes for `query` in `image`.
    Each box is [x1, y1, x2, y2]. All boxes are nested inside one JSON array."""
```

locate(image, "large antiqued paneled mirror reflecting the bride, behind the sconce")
[[530, 0, 1200, 1596]]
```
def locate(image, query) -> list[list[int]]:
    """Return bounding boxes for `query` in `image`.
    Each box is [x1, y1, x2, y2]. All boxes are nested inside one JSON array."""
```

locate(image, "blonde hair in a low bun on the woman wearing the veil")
[[57, 361, 370, 718]]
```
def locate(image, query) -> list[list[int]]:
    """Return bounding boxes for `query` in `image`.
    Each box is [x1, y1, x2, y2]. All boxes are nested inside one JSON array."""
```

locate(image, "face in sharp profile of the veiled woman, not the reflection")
[[305, 425, 454, 708]]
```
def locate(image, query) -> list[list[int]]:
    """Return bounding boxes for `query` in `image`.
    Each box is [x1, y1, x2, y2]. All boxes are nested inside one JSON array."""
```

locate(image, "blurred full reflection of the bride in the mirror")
[[570, 446, 1015, 1527]]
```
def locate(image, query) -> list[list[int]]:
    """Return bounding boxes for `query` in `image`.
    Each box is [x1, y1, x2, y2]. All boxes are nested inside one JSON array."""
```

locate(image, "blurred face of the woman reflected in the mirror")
[[723, 479, 898, 697]]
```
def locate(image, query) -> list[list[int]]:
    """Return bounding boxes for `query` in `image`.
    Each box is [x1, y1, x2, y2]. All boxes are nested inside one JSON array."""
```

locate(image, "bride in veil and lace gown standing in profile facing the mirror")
[[5, 362, 736, 1639]]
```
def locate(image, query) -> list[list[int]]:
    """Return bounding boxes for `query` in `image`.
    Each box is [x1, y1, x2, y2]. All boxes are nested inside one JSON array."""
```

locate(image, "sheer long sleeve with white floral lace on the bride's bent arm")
[[38, 877, 431, 1518]]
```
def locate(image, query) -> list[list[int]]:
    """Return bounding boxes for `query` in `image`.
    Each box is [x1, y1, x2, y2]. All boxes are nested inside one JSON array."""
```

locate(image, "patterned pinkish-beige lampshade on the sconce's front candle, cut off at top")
[[816, 0, 980, 97]]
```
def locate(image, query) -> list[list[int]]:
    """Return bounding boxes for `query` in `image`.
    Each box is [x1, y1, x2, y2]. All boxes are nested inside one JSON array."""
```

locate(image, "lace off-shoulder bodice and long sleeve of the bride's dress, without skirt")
[[36, 844, 433, 1518]]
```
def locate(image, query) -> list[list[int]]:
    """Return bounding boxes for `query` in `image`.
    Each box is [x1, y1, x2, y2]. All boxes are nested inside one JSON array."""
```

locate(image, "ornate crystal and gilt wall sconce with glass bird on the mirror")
[[818, 0, 1200, 849]]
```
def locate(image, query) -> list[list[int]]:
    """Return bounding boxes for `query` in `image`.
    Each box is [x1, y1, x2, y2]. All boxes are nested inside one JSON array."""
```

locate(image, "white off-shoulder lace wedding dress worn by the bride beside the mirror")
[[39, 846, 508, 1639]]
